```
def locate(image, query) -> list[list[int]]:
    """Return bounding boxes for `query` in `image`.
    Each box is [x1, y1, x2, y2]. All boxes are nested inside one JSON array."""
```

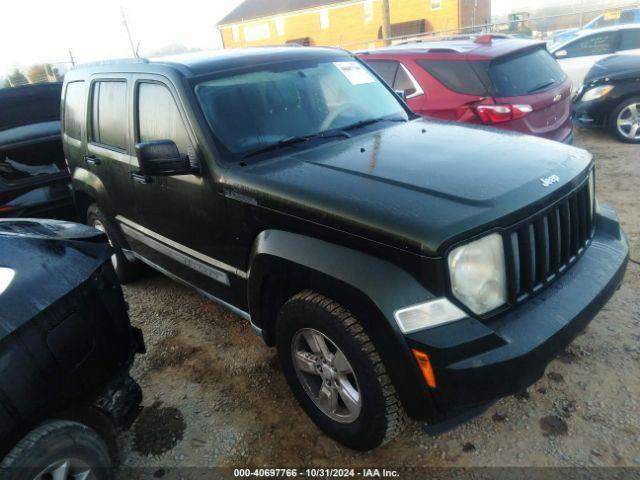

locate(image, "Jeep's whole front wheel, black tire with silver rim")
[[276, 290, 406, 451]]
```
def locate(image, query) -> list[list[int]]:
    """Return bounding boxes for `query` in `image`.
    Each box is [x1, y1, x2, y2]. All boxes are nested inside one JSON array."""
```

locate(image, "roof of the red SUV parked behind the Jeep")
[[358, 37, 544, 60]]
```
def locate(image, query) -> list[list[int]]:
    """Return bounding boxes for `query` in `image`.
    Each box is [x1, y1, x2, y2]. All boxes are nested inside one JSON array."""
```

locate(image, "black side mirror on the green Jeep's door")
[[136, 140, 193, 177]]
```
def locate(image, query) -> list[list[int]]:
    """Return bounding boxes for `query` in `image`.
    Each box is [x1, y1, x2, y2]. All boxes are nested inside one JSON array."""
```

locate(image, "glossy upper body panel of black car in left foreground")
[[0, 219, 111, 340]]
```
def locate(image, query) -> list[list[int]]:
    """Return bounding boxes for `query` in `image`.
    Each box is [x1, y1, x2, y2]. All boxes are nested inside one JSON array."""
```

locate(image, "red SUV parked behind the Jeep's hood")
[[358, 35, 573, 143]]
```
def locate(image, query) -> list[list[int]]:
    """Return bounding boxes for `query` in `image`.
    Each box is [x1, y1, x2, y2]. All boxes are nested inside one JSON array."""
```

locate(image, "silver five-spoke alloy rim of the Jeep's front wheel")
[[291, 328, 362, 423]]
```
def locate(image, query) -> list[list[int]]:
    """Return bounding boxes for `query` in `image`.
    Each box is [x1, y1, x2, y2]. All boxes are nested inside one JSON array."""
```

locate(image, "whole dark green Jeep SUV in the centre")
[[62, 47, 628, 449]]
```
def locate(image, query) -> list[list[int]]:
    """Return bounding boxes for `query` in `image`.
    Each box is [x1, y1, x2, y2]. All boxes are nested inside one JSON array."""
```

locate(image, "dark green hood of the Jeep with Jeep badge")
[[226, 119, 592, 255]]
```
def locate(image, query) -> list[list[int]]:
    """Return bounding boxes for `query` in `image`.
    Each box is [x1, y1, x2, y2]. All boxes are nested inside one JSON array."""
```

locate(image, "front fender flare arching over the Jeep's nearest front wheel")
[[247, 230, 436, 417]]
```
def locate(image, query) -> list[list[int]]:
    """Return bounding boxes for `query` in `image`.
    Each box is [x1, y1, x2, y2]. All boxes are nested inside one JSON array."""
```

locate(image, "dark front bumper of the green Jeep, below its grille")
[[407, 207, 629, 423]]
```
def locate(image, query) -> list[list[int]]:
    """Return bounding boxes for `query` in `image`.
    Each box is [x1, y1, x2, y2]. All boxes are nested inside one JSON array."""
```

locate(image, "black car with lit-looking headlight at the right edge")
[[574, 55, 640, 143]]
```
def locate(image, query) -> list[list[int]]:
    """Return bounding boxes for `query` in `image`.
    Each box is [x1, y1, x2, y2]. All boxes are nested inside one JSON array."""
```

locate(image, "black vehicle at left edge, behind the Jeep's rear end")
[[0, 83, 75, 220]]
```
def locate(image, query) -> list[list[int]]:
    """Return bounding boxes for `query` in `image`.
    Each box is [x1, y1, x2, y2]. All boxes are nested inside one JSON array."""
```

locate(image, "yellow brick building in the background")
[[218, 0, 491, 50]]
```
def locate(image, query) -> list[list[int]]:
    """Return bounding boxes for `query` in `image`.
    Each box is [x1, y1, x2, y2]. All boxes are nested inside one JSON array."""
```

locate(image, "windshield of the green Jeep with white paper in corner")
[[195, 57, 409, 157]]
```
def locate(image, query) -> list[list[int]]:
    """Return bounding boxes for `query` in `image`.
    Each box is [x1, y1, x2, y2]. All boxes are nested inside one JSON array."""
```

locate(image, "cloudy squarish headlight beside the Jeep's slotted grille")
[[449, 233, 507, 315]]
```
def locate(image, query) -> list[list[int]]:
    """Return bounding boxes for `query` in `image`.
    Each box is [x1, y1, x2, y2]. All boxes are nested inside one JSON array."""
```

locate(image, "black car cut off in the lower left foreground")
[[0, 219, 144, 480]]
